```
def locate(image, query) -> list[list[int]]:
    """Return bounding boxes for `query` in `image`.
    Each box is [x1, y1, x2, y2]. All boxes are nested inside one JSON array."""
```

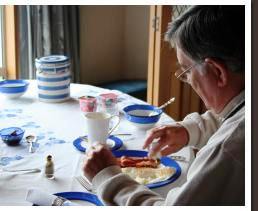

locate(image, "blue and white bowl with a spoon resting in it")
[[123, 104, 163, 129]]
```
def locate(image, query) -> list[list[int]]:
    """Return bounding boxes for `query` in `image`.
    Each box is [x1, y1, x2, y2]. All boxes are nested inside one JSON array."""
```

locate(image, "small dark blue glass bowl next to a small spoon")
[[0, 127, 25, 146]]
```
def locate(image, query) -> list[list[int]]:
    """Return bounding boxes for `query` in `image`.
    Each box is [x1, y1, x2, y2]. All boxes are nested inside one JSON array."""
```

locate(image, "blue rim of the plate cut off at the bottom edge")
[[54, 192, 103, 206]]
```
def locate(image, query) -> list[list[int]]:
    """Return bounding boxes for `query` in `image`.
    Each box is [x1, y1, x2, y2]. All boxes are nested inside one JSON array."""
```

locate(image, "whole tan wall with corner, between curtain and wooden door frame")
[[80, 6, 149, 84]]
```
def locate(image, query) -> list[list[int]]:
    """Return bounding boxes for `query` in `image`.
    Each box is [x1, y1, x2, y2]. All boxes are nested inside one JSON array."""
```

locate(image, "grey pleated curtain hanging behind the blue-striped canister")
[[18, 5, 80, 82]]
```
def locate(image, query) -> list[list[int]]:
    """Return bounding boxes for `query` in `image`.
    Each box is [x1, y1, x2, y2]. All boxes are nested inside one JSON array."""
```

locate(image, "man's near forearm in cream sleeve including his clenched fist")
[[83, 145, 164, 205]]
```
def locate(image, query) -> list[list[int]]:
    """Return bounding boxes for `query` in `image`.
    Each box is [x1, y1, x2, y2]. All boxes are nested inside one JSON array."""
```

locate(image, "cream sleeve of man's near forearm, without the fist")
[[92, 166, 165, 206]]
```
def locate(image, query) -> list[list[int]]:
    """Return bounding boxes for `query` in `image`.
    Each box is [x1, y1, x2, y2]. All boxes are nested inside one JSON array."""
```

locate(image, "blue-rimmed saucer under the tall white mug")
[[73, 136, 123, 152]]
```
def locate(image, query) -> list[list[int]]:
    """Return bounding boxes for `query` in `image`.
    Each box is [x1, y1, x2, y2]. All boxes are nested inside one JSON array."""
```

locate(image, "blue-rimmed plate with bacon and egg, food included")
[[113, 150, 181, 188]]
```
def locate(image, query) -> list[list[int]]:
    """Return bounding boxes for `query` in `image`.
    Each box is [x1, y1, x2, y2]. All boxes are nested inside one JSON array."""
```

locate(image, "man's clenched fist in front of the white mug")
[[83, 144, 117, 181]]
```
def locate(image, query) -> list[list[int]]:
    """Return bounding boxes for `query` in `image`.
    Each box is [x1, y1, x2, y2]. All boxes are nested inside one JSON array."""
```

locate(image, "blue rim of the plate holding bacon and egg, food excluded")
[[113, 150, 181, 188]]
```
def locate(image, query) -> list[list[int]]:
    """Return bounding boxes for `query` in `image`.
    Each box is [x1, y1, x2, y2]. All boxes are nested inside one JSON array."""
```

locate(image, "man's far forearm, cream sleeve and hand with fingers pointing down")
[[143, 111, 220, 156]]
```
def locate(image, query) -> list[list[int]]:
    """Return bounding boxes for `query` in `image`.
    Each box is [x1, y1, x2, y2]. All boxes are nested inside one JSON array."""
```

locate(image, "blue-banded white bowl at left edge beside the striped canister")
[[0, 80, 29, 98]]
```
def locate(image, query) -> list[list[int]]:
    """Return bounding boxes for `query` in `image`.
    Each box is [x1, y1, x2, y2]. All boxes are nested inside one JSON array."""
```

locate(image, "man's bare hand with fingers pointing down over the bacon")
[[143, 123, 189, 156]]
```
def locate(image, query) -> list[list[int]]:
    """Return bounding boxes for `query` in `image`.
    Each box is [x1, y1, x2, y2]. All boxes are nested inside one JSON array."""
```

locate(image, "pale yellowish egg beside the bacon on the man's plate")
[[122, 165, 176, 185]]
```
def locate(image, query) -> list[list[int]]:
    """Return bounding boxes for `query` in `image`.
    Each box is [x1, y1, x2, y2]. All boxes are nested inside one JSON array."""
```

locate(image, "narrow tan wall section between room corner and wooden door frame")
[[122, 6, 150, 79]]
